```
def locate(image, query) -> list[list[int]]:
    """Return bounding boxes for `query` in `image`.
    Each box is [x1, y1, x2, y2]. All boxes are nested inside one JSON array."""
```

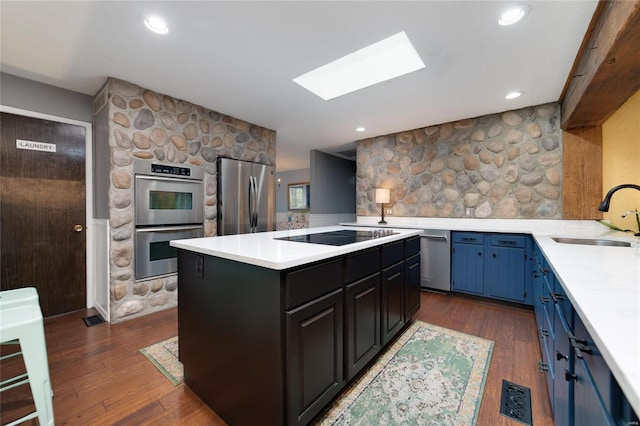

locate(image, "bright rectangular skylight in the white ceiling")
[[293, 31, 424, 101]]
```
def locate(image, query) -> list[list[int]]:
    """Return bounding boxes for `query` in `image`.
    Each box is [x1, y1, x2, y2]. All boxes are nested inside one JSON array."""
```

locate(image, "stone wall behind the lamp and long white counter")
[[356, 103, 562, 219]]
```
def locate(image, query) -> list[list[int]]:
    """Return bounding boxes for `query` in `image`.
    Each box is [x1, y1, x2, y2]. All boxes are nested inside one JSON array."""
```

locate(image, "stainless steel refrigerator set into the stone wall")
[[217, 158, 276, 235]]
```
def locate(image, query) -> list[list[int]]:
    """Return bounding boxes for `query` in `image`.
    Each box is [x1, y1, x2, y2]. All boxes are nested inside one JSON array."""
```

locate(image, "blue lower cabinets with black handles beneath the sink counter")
[[532, 243, 638, 426]]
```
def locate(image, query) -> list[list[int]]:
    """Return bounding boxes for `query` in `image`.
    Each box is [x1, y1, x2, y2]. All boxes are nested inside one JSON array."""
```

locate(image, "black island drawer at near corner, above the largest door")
[[285, 259, 343, 309]]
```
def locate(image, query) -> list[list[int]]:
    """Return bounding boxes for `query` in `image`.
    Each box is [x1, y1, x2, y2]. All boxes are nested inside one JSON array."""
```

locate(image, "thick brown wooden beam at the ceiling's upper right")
[[560, 0, 640, 130]]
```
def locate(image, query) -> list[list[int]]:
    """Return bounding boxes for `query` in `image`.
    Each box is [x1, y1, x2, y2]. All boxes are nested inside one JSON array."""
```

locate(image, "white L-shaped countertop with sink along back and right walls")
[[357, 216, 640, 414]]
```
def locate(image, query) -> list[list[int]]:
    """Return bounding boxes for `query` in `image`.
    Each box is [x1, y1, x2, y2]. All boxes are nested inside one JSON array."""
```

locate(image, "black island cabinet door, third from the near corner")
[[381, 262, 404, 345]]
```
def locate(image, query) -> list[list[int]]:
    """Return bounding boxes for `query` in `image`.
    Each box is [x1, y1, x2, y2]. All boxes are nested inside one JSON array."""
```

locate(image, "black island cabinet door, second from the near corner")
[[345, 272, 381, 380]]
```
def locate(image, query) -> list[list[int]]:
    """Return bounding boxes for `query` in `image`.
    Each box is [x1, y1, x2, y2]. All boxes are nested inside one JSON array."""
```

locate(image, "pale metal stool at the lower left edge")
[[0, 287, 54, 426]]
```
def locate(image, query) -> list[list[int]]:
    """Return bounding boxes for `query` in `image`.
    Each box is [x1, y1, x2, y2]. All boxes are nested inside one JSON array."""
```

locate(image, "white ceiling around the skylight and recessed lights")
[[0, 0, 597, 171]]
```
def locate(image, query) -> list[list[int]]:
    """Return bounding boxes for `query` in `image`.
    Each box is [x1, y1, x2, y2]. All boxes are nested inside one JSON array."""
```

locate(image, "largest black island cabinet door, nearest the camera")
[[286, 289, 345, 424]]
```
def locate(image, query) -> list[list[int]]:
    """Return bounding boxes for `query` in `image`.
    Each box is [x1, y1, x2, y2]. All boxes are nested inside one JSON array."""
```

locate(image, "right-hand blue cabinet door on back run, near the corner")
[[488, 247, 526, 303]]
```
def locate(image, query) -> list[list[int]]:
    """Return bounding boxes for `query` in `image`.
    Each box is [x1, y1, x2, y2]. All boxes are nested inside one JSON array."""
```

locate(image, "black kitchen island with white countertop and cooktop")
[[171, 226, 420, 425]]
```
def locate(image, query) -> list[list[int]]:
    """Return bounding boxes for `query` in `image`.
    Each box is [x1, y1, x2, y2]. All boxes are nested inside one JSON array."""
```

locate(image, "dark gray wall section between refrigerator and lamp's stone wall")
[[310, 150, 356, 214]]
